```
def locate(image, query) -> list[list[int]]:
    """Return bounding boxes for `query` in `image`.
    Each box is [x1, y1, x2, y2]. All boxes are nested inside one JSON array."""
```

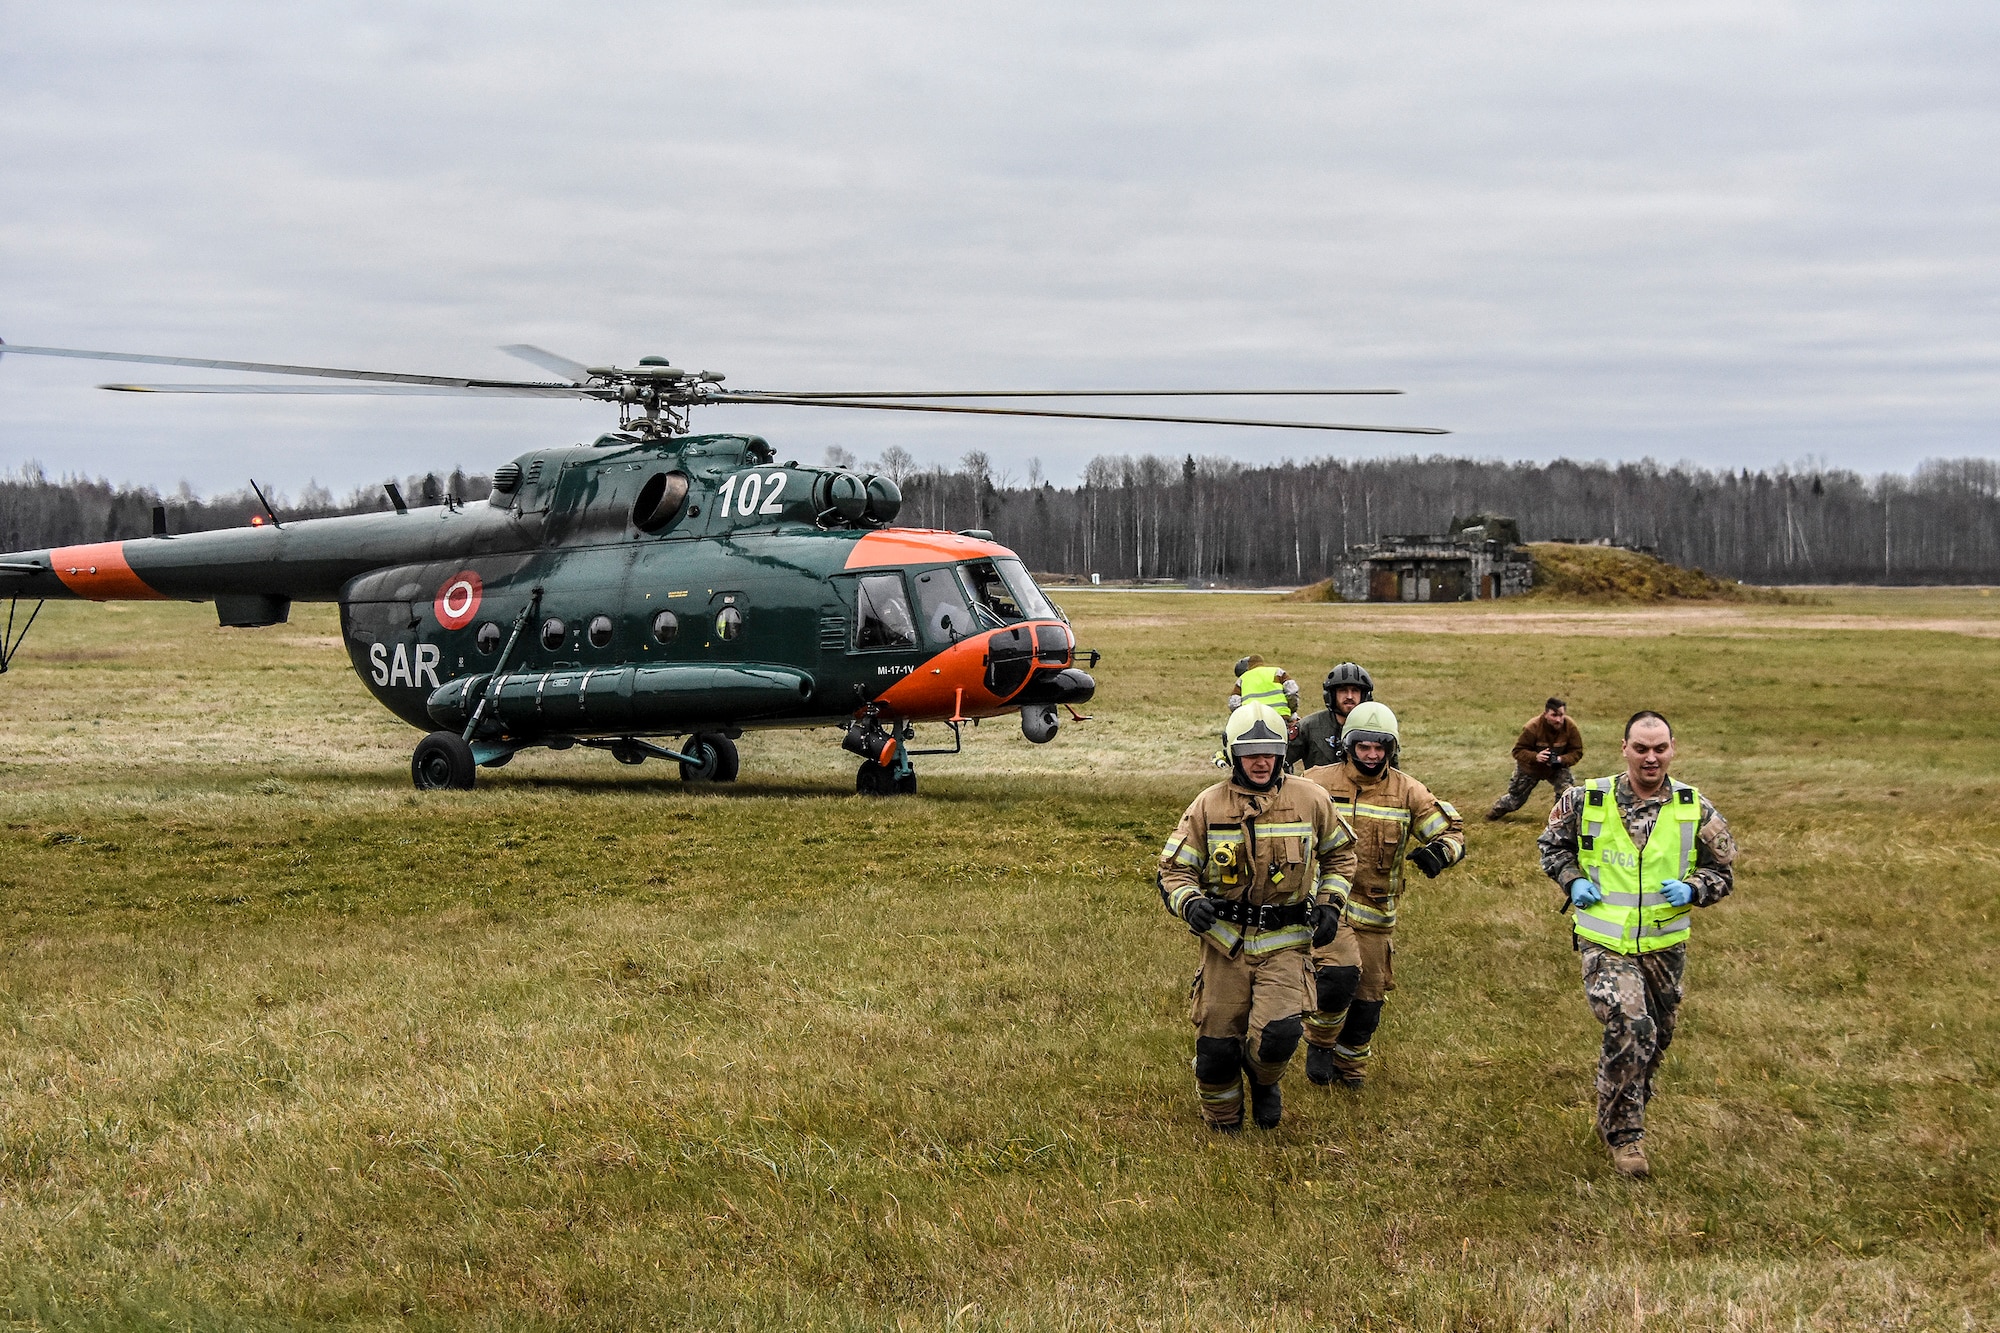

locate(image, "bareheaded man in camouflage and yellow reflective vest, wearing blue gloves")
[[1536, 709, 1736, 1179]]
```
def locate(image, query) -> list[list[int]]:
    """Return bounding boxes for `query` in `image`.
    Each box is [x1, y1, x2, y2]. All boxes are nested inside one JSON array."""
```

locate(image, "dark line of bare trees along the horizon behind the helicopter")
[[0, 446, 2000, 584]]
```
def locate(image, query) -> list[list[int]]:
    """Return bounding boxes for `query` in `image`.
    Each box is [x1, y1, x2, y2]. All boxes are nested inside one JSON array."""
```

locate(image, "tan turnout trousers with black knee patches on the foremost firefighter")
[[1188, 937, 1312, 1125]]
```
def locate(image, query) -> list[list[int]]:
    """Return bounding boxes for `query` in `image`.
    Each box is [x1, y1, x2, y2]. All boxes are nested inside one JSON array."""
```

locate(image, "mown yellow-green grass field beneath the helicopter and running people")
[[0, 590, 2000, 1329]]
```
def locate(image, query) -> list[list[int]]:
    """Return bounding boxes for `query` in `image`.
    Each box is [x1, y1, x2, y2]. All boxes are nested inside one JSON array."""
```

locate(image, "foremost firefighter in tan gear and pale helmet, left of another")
[[1160, 703, 1354, 1131]]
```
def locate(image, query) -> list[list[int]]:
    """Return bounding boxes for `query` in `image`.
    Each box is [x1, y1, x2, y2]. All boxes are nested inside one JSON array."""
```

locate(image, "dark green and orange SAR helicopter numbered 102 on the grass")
[[0, 342, 1446, 797]]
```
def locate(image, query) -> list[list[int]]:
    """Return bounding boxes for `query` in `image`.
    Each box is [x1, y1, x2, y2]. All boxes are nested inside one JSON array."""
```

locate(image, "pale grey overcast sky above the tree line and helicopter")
[[0, 0, 2000, 492]]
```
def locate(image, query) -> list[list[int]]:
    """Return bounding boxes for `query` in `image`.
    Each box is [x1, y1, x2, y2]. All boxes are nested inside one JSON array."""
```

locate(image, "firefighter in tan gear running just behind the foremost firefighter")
[[1306, 703, 1466, 1089]]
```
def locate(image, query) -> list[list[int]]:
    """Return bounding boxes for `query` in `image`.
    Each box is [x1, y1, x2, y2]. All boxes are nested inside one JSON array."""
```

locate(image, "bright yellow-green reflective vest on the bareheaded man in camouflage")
[[1576, 779, 1702, 953]]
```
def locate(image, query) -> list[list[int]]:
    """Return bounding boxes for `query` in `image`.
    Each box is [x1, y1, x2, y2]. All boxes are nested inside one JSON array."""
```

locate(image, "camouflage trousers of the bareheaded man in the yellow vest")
[[1580, 941, 1688, 1147]]
